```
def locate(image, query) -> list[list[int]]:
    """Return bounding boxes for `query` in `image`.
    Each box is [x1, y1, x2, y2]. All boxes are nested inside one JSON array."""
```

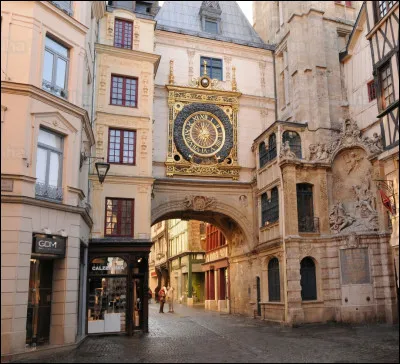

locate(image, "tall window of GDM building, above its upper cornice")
[[42, 36, 69, 98]]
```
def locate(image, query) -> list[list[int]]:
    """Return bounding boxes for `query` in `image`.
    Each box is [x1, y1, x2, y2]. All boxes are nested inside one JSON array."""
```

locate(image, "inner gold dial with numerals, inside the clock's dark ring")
[[182, 111, 225, 157]]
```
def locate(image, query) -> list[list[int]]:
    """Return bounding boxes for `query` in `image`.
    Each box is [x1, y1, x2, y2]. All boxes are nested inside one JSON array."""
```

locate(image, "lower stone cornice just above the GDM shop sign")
[[1, 194, 93, 228]]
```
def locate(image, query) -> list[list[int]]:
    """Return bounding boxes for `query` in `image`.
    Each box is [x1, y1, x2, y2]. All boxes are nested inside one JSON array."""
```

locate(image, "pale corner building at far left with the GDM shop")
[[1, 1, 105, 359]]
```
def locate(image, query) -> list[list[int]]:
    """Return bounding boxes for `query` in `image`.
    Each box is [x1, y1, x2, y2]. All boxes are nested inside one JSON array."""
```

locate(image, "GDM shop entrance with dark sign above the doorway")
[[26, 234, 66, 348]]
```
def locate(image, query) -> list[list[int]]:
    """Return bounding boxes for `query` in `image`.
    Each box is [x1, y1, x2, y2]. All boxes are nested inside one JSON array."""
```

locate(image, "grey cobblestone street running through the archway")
[[14, 303, 399, 363]]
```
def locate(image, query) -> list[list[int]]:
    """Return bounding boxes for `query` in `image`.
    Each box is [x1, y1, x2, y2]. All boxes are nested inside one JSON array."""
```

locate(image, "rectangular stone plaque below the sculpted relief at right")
[[340, 248, 371, 284]]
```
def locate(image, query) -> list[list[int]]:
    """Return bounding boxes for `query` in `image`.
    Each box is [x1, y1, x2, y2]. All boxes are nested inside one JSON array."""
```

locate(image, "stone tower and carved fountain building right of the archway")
[[252, 1, 397, 323]]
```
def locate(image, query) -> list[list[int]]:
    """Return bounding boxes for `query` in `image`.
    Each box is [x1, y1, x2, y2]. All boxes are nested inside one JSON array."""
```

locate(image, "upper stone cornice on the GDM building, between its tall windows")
[[1, 81, 95, 145]]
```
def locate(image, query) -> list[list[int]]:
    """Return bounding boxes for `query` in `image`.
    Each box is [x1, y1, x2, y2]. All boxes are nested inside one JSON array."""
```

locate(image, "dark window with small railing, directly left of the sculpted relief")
[[296, 183, 317, 232]]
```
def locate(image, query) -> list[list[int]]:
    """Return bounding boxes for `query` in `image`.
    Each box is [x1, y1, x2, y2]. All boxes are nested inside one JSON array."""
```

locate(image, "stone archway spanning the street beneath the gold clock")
[[151, 178, 257, 255]]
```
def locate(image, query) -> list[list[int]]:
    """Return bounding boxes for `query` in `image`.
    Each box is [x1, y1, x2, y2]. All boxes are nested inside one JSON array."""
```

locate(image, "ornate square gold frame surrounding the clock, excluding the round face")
[[165, 62, 241, 180]]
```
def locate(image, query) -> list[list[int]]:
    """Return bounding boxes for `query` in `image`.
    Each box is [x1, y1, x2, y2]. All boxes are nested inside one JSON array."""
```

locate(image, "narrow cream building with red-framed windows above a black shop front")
[[87, 1, 160, 335]]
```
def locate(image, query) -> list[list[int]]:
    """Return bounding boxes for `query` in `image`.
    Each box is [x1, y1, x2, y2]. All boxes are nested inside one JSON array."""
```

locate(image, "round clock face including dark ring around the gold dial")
[[174, 103, 233, 164]]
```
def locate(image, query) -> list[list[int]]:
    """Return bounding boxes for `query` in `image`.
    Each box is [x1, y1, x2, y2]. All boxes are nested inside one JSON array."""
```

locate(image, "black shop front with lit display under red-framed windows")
[[87, 239, 151, 335]]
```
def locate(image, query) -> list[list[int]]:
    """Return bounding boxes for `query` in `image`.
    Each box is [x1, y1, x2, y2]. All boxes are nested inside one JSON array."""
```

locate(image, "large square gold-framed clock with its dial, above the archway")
[[165, 72, 241, 180]]
